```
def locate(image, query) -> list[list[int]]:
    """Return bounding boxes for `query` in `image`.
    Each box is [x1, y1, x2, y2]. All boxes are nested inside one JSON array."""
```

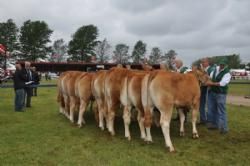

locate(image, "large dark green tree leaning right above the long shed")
[[68, 25, 98, 62]]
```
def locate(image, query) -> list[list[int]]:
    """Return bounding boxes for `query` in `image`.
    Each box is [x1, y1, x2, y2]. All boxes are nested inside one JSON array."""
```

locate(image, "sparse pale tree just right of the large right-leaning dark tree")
[[95, 39, 111, 63]]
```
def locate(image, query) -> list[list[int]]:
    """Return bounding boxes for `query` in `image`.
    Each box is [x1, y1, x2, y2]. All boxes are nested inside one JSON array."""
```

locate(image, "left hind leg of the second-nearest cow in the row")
[[123, 106, 131, 141]]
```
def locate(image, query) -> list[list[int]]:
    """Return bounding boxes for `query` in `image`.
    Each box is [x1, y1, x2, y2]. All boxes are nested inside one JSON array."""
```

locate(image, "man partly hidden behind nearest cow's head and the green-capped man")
[[199, 58, 215, 125]]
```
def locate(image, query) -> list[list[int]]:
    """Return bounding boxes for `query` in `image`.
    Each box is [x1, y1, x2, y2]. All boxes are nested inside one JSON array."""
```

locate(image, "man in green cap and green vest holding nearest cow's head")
[[207, 59, 231, 134]]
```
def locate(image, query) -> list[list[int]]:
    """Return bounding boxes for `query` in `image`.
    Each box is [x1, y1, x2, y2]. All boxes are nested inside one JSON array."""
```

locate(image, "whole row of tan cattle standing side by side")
[[57, 64, 209, 152]]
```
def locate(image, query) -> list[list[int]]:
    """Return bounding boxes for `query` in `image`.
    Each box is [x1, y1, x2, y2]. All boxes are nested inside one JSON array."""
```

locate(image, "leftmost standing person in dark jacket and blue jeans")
[[13, 63, 26, 112]]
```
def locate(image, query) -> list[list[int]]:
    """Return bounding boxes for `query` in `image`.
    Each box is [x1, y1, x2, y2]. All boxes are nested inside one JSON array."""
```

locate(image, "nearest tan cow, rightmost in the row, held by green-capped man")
[[142, 70, 208, 152]]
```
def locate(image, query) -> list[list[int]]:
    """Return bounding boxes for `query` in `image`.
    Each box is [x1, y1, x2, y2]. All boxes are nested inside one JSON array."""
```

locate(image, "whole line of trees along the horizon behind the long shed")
[[0, 19, 246, 68]]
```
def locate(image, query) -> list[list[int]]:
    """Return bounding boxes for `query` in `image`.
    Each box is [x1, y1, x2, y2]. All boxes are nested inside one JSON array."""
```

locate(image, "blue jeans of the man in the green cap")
[[207, 92, 228, 132]]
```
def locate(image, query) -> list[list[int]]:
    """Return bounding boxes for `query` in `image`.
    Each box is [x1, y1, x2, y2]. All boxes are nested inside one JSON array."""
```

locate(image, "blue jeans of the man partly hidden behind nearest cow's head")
[[200, 86, 207, 122]]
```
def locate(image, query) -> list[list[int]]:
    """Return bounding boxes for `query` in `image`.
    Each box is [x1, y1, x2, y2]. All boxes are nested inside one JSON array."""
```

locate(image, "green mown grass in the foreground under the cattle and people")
[[0, 88, 250, 166]]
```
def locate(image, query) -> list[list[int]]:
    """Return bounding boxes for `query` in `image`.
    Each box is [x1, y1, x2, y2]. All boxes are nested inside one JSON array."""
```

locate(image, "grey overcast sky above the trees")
[[0, 0, 250, 65]]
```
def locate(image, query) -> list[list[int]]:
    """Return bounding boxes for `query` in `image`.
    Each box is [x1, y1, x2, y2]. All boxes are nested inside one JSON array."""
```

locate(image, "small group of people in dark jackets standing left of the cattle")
[[13, 62, 40, 112]]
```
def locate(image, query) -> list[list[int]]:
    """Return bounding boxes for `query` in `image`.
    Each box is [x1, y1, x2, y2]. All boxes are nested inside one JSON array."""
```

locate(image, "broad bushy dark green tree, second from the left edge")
[[20, 20, 53, 61]]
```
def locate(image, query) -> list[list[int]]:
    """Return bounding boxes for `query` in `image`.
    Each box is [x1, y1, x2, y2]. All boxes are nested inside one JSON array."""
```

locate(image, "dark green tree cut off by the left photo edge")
[[0, 19, 18, 56]]
